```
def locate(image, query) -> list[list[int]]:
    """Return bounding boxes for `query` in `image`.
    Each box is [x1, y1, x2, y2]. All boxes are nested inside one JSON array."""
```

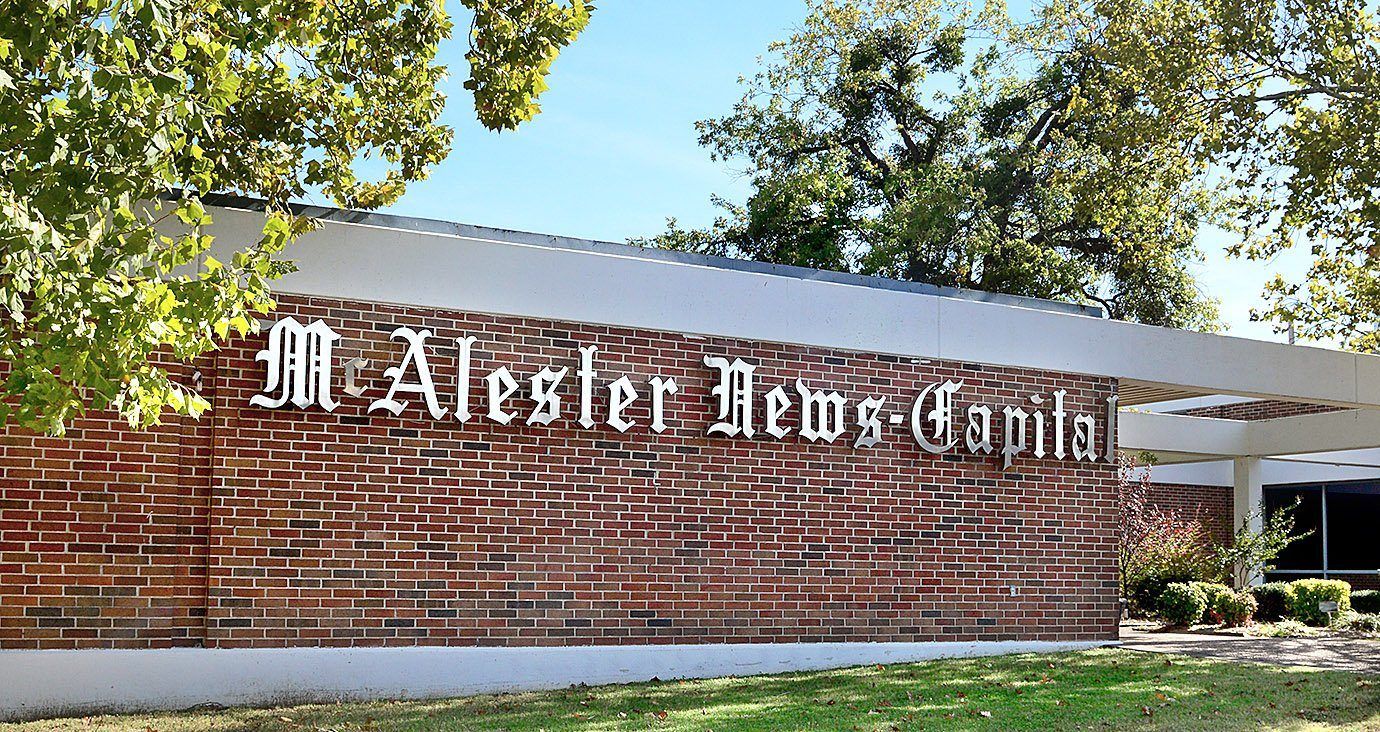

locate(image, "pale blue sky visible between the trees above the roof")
[[375, 0, 1307, 340]]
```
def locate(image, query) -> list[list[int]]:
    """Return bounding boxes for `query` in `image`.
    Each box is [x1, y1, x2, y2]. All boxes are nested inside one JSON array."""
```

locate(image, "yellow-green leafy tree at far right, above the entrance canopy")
[[1064, 0, 1380, 352]]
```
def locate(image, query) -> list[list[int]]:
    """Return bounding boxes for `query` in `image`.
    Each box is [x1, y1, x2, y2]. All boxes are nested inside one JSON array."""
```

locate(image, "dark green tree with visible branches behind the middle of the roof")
[[642, 0, 1220, 327]]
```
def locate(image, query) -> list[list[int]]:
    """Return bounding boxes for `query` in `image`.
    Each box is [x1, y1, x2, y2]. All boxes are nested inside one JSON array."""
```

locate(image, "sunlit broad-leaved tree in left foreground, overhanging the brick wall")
[[0, 0, 592, 432]]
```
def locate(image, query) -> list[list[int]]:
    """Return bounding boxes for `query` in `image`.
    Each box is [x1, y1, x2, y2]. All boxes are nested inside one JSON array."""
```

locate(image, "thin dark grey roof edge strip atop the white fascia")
[[201, 193, 1105, 318]]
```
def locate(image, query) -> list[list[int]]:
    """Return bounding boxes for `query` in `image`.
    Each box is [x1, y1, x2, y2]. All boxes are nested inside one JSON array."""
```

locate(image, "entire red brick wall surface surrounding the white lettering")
[[0, 292, 1116, 648]]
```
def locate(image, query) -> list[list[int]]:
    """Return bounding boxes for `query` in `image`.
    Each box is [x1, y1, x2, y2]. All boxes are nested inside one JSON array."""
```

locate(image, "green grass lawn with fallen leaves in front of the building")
[[10, 649, 1380, 732]]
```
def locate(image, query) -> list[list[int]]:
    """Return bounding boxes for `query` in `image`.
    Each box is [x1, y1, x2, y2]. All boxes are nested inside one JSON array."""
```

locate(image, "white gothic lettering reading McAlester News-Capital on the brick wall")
[[250, 318, 1116, 470]]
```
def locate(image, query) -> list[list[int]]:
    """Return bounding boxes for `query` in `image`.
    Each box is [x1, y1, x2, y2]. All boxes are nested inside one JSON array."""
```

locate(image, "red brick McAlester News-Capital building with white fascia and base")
[[0, 199, 1380, 718]]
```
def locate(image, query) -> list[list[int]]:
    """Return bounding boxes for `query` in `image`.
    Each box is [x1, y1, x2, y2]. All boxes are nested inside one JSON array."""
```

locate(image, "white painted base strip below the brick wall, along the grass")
[[0, 641, 1115, 721]]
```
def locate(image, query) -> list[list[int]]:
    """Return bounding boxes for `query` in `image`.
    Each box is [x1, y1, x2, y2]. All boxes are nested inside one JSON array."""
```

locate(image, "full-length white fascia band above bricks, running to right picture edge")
[[200, 209, 1380, 407]]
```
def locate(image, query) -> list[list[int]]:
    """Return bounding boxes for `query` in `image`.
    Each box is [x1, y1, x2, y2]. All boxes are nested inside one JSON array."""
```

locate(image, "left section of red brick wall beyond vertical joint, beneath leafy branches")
[[0, 359, 210, 648]]
